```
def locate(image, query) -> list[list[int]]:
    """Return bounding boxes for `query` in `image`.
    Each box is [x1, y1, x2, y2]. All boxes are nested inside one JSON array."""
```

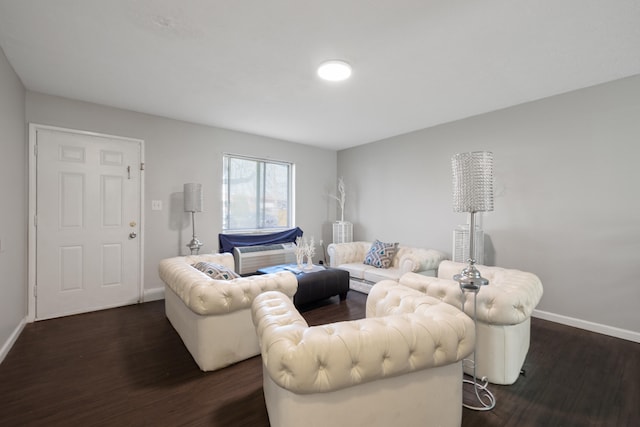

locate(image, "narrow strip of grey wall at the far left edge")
[[0, 49, 27, 361]]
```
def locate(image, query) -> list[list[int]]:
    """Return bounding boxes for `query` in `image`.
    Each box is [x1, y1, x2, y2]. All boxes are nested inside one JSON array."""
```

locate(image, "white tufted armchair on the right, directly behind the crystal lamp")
[[399, 261, 542, 385]]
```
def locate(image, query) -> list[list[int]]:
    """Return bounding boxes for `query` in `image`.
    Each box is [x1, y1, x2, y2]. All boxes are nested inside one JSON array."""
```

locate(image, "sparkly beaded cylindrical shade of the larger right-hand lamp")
[[451, 151, 493, 212]]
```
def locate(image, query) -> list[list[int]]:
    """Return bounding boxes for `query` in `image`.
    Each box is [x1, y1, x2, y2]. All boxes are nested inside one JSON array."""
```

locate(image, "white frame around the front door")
[[27, 123, 145, 323]]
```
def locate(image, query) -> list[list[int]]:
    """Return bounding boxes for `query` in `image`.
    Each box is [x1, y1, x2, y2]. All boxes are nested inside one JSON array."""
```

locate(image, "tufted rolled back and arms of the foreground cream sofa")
[[252, 288, 475, 394]]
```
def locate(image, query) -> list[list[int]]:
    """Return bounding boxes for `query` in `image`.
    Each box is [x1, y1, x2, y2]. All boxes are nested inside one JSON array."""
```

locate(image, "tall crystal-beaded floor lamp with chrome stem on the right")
[[451, 151, 496, 411]]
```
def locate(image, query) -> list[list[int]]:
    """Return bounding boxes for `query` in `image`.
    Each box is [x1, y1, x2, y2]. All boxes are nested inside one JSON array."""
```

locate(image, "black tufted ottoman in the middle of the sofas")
[[258, 265, 349, 307]]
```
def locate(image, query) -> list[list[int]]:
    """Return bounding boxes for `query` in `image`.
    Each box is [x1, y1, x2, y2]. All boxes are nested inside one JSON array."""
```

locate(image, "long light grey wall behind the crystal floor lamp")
[[338, 76, 640, 339]]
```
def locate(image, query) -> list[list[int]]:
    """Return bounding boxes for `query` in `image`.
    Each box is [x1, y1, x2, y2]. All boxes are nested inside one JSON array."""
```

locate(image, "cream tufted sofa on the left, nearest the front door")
[[159, 253, 298, 371]]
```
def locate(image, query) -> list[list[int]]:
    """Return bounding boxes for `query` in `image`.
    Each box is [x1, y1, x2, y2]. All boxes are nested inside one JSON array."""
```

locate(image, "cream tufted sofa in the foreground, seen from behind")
[[252, 281, 475, 427]]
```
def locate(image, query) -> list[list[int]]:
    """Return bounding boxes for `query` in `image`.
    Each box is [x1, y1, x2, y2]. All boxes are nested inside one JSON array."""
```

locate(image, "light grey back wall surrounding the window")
[[26, 91, 337, 291]]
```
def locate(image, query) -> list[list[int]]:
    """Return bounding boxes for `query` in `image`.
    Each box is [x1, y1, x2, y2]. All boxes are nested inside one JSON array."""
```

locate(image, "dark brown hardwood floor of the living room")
[[0, 292, 640, 427]]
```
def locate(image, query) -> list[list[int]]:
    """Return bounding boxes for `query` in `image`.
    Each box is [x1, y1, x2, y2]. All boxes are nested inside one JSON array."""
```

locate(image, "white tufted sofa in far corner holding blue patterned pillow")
[[327, 241, 447, 293]]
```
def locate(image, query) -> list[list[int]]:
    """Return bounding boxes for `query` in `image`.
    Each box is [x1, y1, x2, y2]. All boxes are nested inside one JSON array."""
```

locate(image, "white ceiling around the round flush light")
[[0, 0, 640, 149]]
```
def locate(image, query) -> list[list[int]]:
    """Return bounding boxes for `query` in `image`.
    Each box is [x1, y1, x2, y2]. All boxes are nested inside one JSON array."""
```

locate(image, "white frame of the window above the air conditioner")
[[221, 153, 296, 234]]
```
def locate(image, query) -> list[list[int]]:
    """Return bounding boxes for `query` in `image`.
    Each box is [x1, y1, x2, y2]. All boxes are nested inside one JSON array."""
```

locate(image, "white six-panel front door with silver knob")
[[35, 128, 142, 319]]
